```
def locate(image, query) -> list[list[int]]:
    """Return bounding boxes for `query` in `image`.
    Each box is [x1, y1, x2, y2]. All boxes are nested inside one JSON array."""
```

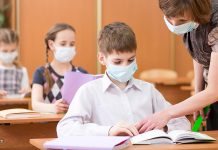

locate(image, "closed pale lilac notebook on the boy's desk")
[[43, 136, 131, 150]]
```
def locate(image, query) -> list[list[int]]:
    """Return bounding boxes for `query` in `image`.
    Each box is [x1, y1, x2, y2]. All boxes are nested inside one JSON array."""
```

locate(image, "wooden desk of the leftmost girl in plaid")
[[0, 98, 31, 110]]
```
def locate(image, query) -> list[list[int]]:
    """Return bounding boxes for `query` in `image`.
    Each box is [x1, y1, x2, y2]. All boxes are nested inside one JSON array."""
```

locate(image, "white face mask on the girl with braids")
[[54, 46, 76, 63]]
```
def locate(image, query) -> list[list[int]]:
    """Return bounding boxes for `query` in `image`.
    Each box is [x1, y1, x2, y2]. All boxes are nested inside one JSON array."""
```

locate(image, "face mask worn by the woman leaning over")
[[164, 16, 199, 35]]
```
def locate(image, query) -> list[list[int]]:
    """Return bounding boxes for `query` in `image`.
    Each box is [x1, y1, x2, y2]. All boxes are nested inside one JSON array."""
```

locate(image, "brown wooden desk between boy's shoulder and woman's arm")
[[144, 77, 191, 104]]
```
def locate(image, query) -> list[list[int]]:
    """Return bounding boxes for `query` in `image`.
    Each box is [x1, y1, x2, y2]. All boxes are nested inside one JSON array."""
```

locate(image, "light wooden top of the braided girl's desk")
[[0, 114, 64, 124]]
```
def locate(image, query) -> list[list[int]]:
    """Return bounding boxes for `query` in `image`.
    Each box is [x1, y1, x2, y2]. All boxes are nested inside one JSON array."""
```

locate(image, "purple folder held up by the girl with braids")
[[61, 71, 103, 104]]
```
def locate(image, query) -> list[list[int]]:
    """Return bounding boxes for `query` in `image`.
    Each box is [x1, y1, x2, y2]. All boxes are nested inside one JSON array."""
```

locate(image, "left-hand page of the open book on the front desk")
[[130, 130, 171, 144]]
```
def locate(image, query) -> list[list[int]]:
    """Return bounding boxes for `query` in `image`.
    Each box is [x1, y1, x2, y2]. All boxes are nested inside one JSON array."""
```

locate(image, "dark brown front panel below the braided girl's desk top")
[[0, 122, 57, 150]]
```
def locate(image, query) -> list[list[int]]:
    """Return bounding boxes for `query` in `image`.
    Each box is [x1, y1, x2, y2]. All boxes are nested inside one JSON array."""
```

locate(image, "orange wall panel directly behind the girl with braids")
[[19, 0, 96, 79]]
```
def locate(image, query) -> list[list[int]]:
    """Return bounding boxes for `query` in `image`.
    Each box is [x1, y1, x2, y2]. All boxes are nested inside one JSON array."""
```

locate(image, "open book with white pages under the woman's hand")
[[131, 130, 216, 144]]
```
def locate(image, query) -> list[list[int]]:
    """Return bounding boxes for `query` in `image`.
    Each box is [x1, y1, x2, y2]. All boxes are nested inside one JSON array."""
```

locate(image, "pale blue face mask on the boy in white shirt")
[[106, 59, 138, 82]]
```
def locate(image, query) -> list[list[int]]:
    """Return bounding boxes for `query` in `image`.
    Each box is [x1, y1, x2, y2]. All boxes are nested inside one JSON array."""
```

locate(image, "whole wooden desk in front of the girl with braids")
[[0, 114, 64, 150]]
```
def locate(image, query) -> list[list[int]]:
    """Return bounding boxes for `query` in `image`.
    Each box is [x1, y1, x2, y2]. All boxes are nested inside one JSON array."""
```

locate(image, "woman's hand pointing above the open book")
[[135, 111, 170, 133]]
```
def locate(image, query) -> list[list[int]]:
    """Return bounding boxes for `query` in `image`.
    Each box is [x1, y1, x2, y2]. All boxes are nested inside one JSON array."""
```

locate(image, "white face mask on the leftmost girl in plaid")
[[0, 50, 18, 64]]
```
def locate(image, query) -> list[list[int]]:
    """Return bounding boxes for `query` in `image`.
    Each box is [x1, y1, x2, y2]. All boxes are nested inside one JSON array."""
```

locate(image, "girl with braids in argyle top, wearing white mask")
[[32, 23, 86, 113]]
